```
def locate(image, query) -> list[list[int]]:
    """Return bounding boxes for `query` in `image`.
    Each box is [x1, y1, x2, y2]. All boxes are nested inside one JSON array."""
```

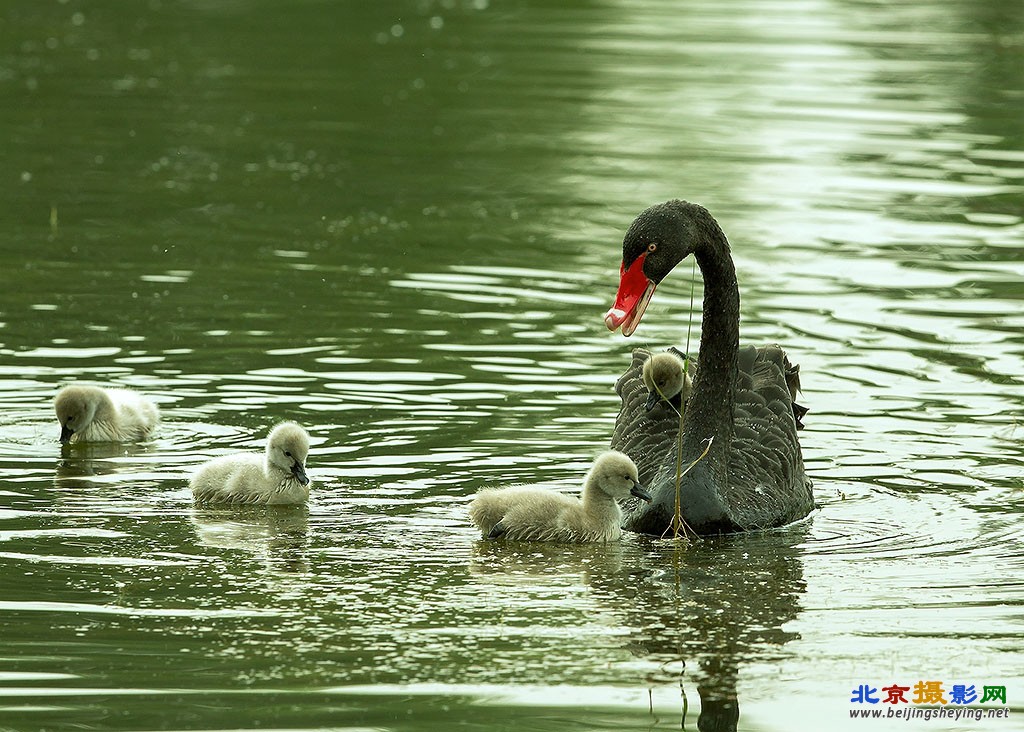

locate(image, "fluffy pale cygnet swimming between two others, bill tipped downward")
[[190, 422, 312, 505]]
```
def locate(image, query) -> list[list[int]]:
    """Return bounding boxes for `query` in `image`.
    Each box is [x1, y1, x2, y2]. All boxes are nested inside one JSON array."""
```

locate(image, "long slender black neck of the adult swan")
[[683, 223, 739, 484]]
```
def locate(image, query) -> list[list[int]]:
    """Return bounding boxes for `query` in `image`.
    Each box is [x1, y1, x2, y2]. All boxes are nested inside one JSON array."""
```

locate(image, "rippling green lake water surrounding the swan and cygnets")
[[0, 0, 1024, 732]]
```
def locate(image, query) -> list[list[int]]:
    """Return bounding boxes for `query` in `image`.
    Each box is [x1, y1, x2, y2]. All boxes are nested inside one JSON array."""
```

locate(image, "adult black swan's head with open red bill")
[[604, 201, 718, 336]]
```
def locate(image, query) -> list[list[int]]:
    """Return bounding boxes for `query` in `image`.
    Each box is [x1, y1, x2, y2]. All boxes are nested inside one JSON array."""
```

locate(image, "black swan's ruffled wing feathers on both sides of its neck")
[[610, 346, 813, 531]]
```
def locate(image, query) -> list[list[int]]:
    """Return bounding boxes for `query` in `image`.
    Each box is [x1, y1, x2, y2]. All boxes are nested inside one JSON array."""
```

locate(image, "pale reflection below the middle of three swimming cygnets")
[[188, 505, 309, 573]]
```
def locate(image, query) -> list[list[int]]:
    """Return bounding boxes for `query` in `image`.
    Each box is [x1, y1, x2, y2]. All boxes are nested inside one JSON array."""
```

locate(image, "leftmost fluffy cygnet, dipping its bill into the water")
[[53, 385, 160, 442]]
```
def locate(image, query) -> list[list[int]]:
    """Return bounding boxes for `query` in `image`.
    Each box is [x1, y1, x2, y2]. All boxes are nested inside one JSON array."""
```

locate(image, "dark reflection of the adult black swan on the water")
[[606, 526, 807, 732]]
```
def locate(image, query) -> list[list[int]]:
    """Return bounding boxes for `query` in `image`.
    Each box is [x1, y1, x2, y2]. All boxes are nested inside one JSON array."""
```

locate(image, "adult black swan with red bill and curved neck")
[[604, 201, 814, 535]]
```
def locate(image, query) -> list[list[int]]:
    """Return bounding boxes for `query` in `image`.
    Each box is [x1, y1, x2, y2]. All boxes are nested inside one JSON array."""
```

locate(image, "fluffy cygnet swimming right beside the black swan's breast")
[[469, 450, 650, 544]]
